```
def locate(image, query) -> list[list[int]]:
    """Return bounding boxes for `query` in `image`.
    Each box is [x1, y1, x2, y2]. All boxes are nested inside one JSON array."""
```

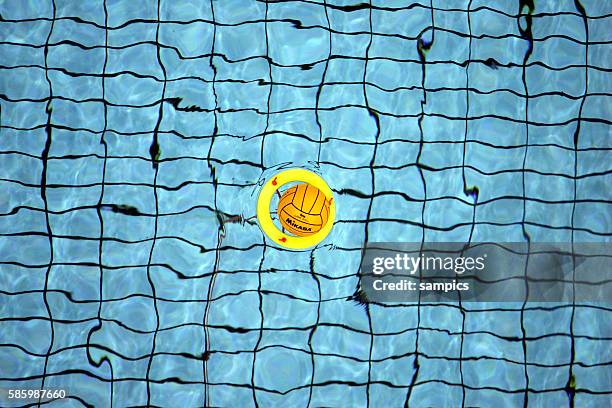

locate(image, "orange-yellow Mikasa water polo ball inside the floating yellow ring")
[[277, 183, 330, 237]]
